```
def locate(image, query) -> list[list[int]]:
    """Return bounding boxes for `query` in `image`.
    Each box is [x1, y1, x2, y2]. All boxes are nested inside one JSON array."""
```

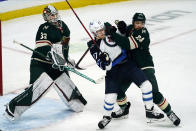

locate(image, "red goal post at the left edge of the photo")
[[0, 20, 3, 96]]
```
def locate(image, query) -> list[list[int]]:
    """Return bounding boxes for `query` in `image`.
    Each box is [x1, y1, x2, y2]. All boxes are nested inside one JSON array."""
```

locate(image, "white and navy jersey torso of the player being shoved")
[[87, 33, 130, 70]]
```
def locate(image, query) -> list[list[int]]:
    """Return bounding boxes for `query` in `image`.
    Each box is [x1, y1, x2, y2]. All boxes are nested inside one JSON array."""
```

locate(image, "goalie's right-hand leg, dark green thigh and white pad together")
[[41, 61, 87, 112]]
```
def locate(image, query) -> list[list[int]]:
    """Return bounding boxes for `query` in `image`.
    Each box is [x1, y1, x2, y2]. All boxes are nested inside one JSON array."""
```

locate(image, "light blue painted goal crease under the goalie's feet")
[[0, 94, 73, 131]]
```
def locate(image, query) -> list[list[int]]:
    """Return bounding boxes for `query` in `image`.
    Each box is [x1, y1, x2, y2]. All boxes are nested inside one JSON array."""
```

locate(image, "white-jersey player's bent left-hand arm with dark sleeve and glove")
[[87, 40, 112, 70]]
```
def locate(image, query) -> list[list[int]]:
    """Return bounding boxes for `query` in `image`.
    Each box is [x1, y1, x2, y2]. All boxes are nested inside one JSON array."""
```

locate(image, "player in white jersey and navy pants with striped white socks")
[[87, 20, 164, 129]]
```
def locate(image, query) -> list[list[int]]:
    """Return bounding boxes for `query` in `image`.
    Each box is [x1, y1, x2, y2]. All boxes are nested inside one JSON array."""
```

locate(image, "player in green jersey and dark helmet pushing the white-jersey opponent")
[[114, 13, 180, 126]]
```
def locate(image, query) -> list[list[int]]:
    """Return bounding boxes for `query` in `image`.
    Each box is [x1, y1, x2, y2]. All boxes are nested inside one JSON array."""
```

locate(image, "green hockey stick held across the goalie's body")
[[13, 40, 99, 84]]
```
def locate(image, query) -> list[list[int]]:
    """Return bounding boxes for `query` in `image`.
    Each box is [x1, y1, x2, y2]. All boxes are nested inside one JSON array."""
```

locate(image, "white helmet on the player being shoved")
[[89, 20, 104, 37]]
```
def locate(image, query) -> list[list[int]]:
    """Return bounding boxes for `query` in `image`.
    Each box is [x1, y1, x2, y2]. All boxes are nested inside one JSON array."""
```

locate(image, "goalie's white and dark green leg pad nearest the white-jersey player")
[[53, 73, 87, 112]]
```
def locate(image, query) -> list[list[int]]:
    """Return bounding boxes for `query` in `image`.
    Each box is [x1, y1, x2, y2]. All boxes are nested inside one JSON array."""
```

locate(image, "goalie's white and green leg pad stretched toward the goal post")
[[6, 73, 53, 119]]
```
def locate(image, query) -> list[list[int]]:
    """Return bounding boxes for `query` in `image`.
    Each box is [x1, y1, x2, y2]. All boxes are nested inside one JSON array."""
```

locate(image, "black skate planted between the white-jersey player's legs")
[[111, 102, 131, 119]]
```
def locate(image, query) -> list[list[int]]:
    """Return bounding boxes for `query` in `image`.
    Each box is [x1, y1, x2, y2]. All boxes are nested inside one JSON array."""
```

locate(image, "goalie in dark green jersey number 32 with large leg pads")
[[4, 5, 87, 120]]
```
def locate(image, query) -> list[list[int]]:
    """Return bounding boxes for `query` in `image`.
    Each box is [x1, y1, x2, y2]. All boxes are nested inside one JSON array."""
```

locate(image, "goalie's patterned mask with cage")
[[42, 5, 59, 23]]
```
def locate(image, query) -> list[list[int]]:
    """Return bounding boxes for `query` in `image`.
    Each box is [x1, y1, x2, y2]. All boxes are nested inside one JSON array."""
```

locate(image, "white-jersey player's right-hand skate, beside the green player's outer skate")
[[146, 106, 165, 123]]
